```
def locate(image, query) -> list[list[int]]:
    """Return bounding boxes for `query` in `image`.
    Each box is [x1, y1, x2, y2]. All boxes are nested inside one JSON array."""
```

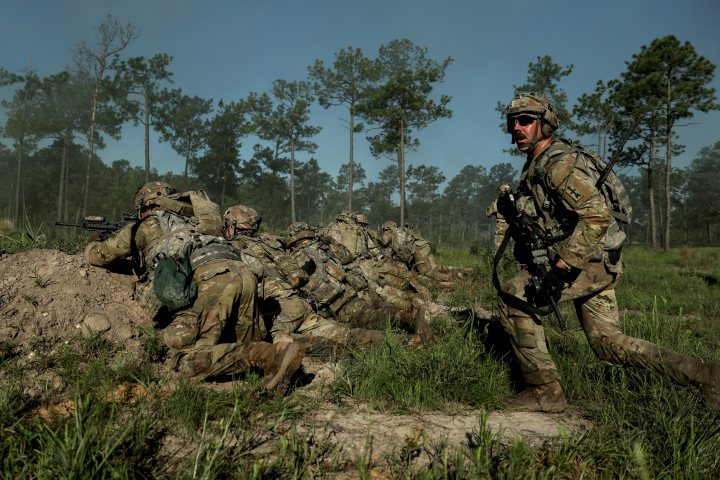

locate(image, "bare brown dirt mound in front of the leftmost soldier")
[[0, 250, 152, 352]]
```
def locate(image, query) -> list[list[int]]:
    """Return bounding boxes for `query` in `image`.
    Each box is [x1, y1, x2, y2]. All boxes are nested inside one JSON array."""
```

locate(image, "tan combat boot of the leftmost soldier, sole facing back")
[[248, 342, 305, 395]]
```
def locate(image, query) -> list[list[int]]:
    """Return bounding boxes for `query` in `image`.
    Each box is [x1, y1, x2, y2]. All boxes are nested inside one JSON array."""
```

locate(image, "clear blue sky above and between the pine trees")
[[0, 0, 720, 188]]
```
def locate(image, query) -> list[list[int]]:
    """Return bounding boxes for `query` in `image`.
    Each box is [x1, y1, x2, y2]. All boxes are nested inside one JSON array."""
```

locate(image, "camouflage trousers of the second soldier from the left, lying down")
[[270, 294, 385, 353]]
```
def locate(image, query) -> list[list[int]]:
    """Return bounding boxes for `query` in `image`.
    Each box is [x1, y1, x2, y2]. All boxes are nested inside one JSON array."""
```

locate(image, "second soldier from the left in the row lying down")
[[225, 205, 383, 350]]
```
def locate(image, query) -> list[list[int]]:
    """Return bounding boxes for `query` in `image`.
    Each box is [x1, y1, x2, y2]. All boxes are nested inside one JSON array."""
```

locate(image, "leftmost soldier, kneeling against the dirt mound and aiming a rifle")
[[85, 182, 304, 392]]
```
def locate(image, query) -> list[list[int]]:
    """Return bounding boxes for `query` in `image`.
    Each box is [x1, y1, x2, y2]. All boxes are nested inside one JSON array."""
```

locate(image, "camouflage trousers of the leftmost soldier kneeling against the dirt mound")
[[163, 260, 268, 377]]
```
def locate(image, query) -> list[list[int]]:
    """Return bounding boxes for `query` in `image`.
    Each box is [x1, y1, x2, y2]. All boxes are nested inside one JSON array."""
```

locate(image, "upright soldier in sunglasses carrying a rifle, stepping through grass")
[[498, 93, 720, 412]]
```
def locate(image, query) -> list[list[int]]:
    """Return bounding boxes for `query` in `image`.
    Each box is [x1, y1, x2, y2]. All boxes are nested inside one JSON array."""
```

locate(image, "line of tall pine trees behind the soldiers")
[[0, 15, 720, 249]]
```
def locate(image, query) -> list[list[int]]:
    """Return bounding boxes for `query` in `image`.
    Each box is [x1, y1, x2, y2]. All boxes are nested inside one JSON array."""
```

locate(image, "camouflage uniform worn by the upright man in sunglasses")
[[498, 96, 720, 411]]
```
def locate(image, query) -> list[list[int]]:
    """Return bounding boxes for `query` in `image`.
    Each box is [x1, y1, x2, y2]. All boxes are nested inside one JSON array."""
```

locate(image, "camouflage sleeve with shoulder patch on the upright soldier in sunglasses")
[[547, 155, 611, 268]]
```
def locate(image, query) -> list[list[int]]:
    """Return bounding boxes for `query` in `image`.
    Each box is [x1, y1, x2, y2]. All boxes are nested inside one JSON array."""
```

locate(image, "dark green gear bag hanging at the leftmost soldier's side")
[[154, 257, 197, 312]]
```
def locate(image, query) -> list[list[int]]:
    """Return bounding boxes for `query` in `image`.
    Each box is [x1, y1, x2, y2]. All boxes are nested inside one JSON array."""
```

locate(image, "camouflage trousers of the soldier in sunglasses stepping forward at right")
[[498, 262, 697, 385]]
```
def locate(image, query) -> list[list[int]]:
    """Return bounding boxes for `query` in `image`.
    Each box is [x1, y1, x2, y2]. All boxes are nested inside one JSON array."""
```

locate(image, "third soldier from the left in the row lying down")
[[286, 222, 426, 335]]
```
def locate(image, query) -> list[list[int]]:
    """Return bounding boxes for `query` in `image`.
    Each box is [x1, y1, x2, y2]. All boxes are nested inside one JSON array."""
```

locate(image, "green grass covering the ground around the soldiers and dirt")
[[0, 242, 720, 480]]
